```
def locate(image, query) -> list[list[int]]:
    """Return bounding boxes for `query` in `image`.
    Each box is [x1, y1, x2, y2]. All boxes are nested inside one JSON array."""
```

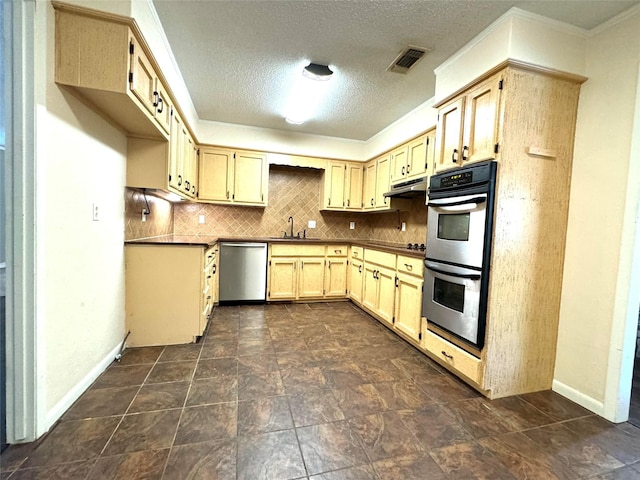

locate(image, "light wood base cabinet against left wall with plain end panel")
[[125, 244, 216, 347]]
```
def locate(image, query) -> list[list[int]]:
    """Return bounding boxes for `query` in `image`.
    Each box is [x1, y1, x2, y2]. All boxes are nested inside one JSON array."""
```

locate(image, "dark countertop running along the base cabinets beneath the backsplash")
[[125, 235, 424, 258]]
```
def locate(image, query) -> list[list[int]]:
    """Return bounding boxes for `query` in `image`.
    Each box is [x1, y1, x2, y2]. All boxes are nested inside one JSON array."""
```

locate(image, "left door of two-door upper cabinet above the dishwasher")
[[198, 148, 233, 202]]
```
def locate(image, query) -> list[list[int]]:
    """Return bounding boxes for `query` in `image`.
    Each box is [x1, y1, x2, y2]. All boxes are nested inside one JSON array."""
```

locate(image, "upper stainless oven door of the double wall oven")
[[426, 193, 487, 268]]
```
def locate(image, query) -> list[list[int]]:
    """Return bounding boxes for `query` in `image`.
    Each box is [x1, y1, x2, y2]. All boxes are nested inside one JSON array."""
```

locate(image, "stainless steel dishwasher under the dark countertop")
[[218, 242, 267, 302]]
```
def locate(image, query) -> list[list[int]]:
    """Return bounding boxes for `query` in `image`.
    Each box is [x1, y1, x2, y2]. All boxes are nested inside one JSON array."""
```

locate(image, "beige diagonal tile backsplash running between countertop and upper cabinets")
[[125, 165, 427, 244]]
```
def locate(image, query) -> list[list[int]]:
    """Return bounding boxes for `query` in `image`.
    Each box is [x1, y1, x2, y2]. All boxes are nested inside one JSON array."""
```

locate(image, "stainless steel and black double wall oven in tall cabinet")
[[422, 162, 497, 353]]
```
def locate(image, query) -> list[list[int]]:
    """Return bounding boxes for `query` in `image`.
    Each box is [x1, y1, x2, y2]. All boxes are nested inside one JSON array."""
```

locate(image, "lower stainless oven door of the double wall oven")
[[422, 260, 484, 349]]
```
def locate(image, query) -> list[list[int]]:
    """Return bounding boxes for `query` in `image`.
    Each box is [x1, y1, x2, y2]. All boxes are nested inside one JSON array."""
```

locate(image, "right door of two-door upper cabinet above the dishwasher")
[[231, 152, 269, 205]]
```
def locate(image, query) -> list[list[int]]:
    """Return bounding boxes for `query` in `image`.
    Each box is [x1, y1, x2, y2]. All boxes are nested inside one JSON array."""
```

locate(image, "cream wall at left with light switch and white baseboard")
[[35, 2, 126, 433]]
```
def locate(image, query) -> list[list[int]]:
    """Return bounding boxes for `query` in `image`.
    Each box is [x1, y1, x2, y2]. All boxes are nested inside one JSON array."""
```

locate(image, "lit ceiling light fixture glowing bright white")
[[285, 62, 333, 125]]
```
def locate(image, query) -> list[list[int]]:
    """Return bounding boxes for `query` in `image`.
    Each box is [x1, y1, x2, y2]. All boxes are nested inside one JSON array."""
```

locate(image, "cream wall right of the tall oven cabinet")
[[554, 8, 640, 421]]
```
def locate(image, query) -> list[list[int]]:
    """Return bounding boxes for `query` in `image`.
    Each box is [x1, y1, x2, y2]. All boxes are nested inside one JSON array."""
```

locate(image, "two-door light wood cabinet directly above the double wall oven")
[[435, 73, 502, 172]]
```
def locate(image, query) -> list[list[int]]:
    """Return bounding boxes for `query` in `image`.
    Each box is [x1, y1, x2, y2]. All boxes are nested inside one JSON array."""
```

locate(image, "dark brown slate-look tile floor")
[[0, 303, 640, 480]]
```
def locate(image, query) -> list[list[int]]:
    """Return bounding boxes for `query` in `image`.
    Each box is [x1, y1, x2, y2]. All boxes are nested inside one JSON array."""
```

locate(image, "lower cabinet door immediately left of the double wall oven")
[[394, 273, 423, 342]]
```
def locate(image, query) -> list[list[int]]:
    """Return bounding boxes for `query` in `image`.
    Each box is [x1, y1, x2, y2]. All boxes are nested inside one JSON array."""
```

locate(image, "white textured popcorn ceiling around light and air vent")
[[154, 0, 638, 140]]
